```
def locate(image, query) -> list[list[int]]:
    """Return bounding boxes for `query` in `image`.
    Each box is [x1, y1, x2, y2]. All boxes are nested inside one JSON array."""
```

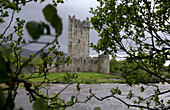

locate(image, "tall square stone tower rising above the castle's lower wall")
[[68, 15, 90, 57]]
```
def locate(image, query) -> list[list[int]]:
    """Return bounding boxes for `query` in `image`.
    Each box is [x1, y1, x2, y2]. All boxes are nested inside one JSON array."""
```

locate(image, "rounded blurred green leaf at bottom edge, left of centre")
[[33, 98, 48, 110]]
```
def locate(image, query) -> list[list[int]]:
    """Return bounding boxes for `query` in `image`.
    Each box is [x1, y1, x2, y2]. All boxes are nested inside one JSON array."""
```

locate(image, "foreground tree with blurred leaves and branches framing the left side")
[[0, 0, 80, 110]]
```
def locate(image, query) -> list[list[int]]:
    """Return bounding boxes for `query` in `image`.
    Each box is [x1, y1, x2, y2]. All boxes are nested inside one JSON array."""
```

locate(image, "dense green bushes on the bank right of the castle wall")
[[110, 57, 160, 85]]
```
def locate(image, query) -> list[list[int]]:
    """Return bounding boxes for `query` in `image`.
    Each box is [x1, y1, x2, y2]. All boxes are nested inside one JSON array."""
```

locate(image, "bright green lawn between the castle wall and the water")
[[25, 72, 125, 84]]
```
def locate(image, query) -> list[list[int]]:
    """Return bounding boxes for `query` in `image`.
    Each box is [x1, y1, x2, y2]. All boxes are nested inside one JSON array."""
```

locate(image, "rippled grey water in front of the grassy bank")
[[15, 84, 170, 110]]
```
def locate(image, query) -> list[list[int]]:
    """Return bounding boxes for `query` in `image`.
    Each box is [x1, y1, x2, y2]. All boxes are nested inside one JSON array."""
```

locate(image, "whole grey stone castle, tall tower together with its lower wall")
[[50, 15, 110, 74]]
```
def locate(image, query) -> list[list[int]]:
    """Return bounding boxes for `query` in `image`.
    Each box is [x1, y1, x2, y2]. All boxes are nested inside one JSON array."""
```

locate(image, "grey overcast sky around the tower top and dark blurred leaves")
[[11, 0, 98, 55]]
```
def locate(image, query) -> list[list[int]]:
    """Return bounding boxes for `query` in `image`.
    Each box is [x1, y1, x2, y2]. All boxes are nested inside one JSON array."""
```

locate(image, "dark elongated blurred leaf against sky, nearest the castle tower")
[[43, 4, 62, 37]]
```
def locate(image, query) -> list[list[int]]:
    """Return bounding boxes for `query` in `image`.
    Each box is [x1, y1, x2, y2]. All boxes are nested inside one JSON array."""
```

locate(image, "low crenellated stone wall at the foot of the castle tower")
[[50, 55, 110, 74]]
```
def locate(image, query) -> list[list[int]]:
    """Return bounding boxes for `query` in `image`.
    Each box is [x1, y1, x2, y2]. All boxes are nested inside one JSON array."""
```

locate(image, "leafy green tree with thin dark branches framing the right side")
[[91, 0, 170, 110]]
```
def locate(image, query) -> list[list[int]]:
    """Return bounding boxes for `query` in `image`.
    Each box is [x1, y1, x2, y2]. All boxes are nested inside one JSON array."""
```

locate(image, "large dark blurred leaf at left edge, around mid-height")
[[0, 46, 11, 82]]
